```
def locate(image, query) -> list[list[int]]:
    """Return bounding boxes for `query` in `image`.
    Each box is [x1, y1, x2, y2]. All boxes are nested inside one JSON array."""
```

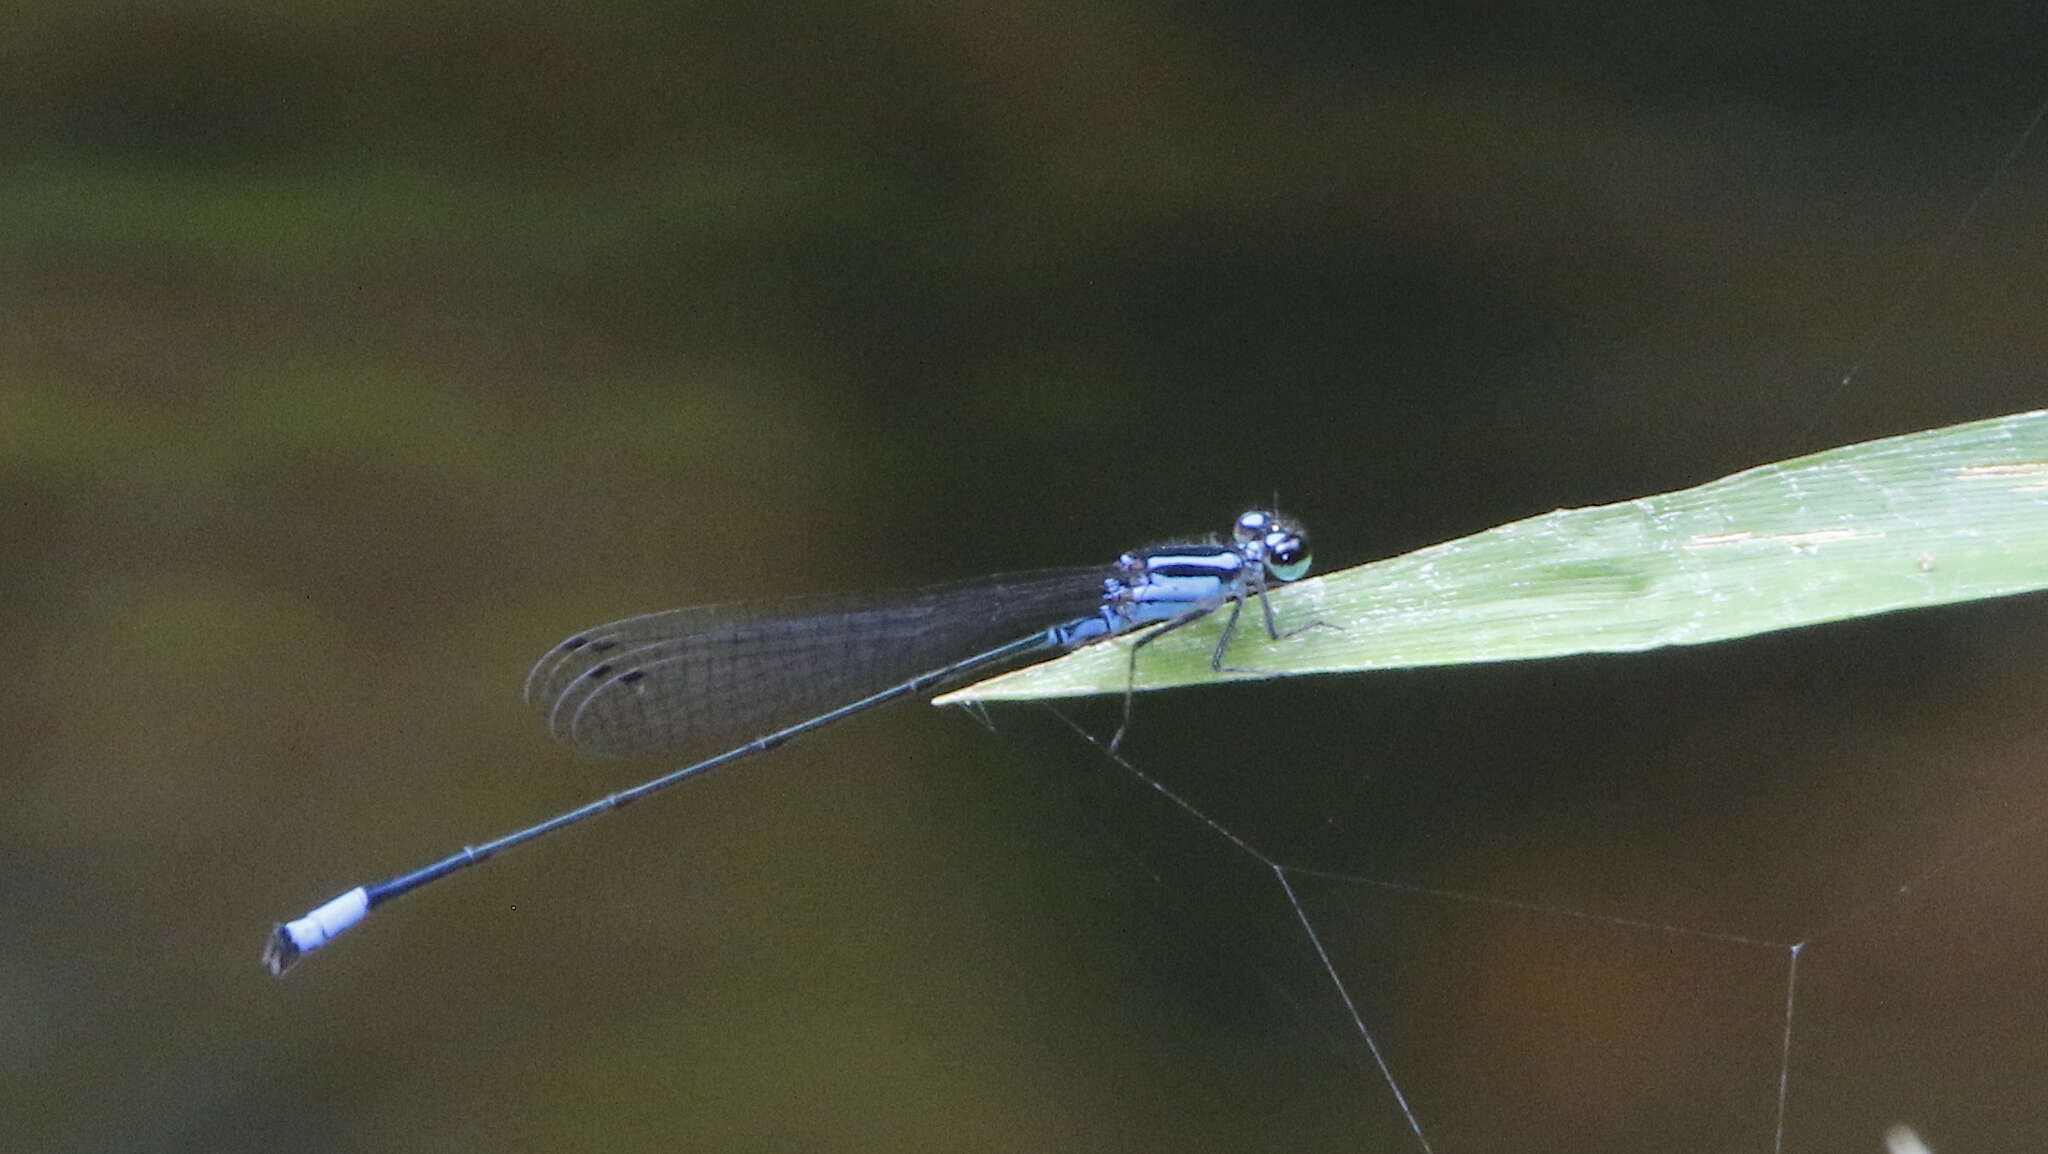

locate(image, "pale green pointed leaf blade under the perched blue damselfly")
[[938, 412, 2048, 705]]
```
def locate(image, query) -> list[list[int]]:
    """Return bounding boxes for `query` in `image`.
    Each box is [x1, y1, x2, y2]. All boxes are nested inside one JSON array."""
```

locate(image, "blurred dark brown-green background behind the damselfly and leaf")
[[12, 0, 2048, 1152]]
